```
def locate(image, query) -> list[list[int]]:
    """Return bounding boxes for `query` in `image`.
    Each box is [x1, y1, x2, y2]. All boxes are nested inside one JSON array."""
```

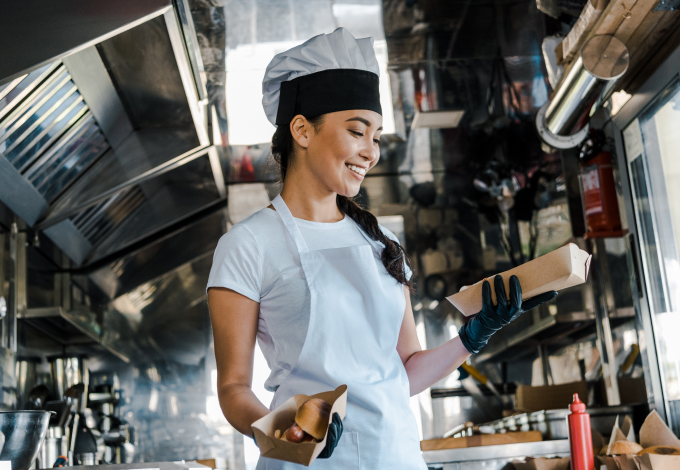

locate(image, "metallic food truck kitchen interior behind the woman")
[[0, 0, 680, 470]]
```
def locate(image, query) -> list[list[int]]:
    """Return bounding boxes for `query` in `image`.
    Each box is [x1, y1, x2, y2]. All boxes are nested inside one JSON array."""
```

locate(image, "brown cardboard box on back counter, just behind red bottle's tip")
[[516, 381, 588, 412]]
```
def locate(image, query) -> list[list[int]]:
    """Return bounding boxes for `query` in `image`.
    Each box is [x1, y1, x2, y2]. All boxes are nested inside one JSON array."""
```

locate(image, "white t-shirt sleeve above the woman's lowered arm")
[[206, 225, 262, 302]]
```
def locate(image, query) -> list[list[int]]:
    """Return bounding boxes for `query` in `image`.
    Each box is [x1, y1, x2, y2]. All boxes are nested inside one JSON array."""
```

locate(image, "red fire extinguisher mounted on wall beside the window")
[[580, 135, 623, 238]]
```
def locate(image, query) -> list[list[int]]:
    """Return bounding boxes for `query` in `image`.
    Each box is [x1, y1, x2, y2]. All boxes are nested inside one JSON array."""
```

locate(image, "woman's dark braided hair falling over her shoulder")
[[272, 115, 413, 292]]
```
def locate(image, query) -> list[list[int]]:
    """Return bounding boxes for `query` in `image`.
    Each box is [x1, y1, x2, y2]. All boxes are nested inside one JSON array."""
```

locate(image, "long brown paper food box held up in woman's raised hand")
[[446, 243, 591, 317]]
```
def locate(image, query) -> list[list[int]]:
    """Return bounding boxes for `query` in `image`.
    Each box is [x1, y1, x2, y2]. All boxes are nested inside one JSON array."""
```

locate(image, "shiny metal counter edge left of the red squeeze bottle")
[[423, 439, 569, 470]]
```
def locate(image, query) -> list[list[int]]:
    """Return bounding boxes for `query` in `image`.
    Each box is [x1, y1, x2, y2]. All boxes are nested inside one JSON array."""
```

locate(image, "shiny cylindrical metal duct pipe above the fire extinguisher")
[[536, 35, 630, 149]]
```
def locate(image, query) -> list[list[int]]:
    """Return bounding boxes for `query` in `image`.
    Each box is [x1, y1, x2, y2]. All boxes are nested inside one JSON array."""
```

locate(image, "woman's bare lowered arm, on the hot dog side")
[[208, 287, 269, 436]]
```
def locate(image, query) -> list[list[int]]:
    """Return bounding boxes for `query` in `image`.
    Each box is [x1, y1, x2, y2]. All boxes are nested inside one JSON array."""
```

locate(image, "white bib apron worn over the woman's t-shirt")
[[257, 196, 427, 470]]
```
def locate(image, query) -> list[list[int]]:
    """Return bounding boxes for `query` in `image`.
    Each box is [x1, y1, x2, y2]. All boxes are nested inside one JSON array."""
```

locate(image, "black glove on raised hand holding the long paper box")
[[458, 276, 557, 354]]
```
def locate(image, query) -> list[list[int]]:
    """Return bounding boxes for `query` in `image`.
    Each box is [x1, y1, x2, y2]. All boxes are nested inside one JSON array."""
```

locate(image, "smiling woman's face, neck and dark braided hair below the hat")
[[272, 109, 413, 290]]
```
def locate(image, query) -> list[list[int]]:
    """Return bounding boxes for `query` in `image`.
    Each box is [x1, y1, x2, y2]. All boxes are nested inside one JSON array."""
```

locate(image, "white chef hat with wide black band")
[[262, 28, 382, 126]]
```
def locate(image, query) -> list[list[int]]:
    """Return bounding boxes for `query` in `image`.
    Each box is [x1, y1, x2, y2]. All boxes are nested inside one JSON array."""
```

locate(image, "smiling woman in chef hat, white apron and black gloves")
[[208, 28, 556, 469]]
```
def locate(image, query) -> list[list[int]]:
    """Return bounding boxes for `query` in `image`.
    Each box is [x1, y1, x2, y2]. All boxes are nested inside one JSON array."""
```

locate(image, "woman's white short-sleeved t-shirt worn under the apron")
[[208, 208, 411, 391]]
